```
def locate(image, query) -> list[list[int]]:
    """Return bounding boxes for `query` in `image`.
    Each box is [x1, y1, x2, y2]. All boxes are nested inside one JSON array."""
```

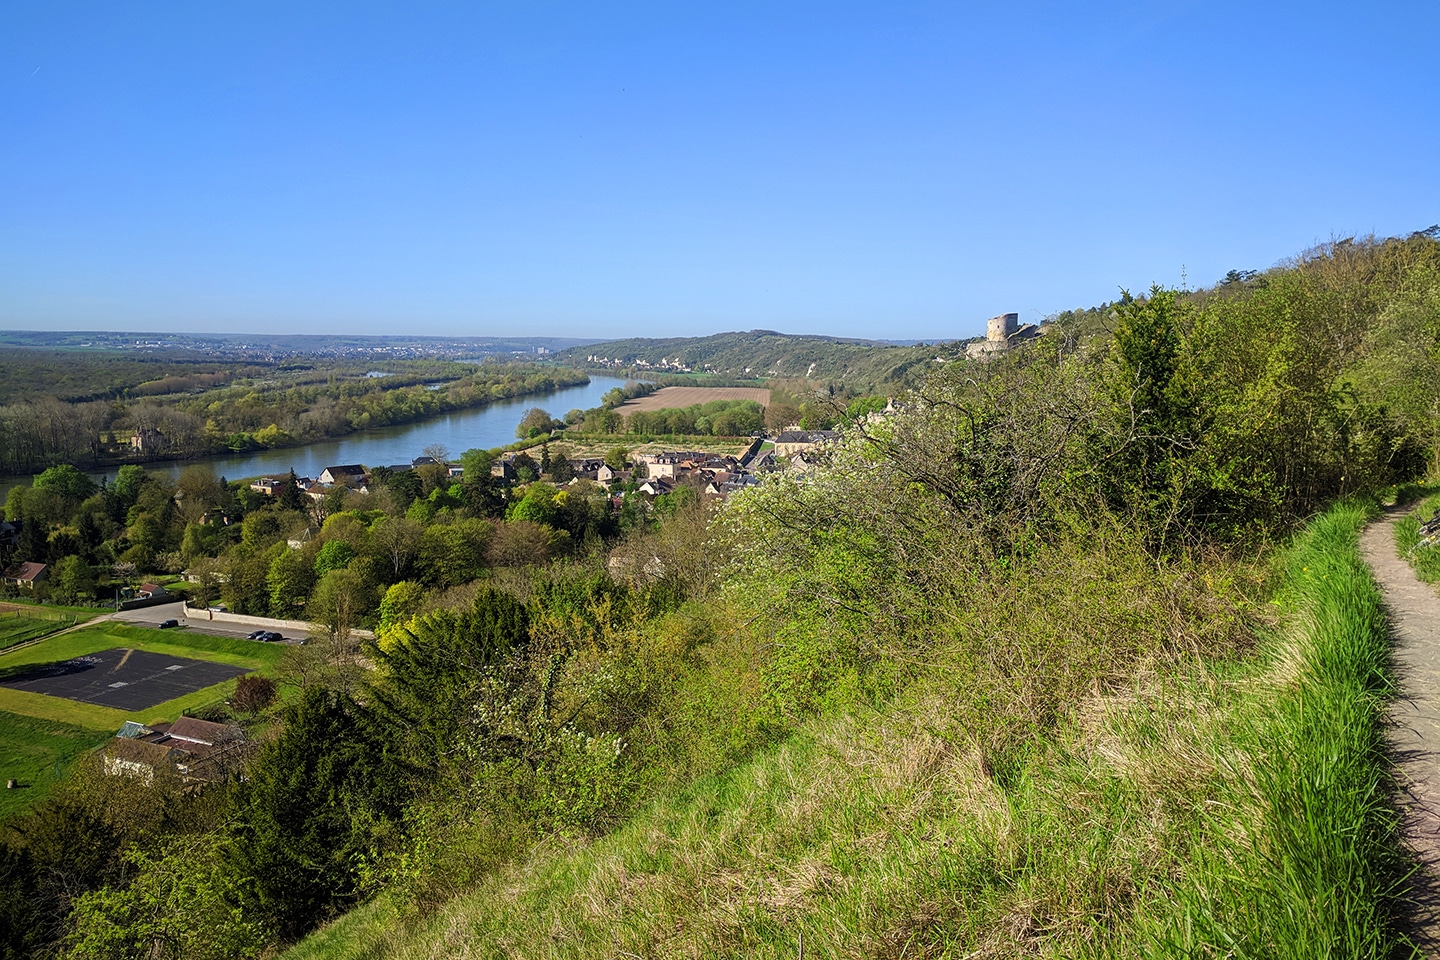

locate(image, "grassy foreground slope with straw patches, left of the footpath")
[[285, 505, 1407, 960]]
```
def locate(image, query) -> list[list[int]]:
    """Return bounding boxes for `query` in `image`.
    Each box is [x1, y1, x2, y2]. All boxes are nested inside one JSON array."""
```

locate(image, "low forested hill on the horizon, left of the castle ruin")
[[557, 330, 963, 389]]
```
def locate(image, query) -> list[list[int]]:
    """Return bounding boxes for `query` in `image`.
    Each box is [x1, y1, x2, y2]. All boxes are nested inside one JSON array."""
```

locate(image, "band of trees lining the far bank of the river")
[[0, 361, 588, 474]]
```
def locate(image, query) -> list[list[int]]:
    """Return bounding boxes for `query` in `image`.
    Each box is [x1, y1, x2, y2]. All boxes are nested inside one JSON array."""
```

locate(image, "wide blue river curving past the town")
[[0, 376, 625, 504]]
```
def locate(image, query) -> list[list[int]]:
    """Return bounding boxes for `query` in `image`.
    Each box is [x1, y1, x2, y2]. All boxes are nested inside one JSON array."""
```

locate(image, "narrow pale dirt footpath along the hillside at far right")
[[1359, 511, 1440, 957]]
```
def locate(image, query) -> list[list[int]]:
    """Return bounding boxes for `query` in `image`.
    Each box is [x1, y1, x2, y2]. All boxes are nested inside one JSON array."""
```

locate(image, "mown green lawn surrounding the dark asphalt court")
[[0, 622, 285, 820]]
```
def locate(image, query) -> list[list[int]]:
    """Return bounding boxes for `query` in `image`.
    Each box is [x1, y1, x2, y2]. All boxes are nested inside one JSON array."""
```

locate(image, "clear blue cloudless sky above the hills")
[[0, 0, 1440, 340]]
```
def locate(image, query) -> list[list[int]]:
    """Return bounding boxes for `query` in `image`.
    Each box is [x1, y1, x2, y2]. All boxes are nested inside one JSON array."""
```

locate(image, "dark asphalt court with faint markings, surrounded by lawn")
[[0, 648, 251, 711]]
